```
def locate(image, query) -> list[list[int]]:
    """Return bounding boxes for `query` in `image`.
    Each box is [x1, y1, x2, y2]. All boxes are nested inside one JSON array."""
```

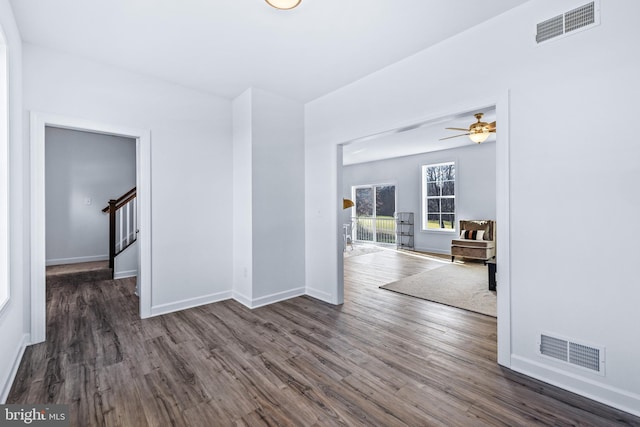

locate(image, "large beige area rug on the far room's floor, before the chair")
[[380, 263, 497, 317]]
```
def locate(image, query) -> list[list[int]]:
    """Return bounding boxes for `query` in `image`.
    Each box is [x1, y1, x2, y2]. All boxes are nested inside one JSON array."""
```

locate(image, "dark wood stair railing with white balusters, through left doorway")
[[102, 188, 138, 272]]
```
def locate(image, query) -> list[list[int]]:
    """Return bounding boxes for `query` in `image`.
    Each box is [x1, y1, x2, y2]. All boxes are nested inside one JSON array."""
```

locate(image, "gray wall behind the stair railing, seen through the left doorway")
[[45, 127, 136, 265]]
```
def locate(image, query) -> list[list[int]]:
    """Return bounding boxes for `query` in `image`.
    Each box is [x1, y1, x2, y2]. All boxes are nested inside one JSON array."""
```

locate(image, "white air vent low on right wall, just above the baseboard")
[[540, 334, 604, 375]]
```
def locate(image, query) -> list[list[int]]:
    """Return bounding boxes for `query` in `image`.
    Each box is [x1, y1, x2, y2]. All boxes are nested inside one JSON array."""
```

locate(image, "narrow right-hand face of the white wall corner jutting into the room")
[[252, 89, 304, 303]]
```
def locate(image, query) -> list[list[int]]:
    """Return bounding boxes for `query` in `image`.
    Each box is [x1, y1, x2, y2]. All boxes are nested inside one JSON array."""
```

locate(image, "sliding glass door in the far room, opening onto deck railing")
[[352, 184, 396, 243]]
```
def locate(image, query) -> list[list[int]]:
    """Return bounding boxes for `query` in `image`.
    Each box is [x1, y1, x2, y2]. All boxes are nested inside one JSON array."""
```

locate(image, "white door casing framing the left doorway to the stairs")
[[30, 112, 151, 343]]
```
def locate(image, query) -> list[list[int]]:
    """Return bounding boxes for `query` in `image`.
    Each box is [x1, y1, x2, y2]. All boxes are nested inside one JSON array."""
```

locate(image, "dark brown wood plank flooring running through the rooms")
[[7, 252, 640, 427]]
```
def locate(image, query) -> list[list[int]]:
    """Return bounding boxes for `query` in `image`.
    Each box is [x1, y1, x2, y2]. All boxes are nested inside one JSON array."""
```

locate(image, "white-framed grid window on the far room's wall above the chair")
[[422, 162, 456, 231]]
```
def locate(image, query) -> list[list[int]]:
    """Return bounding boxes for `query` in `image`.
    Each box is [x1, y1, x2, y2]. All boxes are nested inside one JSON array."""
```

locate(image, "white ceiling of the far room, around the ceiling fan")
[[342, 107, 500, 166]]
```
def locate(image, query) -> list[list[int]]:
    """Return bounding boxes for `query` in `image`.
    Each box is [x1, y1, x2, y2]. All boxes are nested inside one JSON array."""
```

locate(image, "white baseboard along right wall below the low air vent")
[[510, 355, 640, 416]]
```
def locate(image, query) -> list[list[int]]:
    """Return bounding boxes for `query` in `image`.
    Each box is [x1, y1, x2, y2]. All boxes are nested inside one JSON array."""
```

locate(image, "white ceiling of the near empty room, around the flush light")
[[11, 0, 526, 102]]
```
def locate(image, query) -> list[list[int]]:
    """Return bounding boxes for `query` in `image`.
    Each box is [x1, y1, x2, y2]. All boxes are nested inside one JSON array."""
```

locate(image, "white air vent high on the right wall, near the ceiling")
[[536, 1, 600, 43]]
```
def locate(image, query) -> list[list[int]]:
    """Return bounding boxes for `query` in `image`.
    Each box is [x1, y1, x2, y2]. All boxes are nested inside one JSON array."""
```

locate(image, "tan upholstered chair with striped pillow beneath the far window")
[[451, 220, 496, 262]]
